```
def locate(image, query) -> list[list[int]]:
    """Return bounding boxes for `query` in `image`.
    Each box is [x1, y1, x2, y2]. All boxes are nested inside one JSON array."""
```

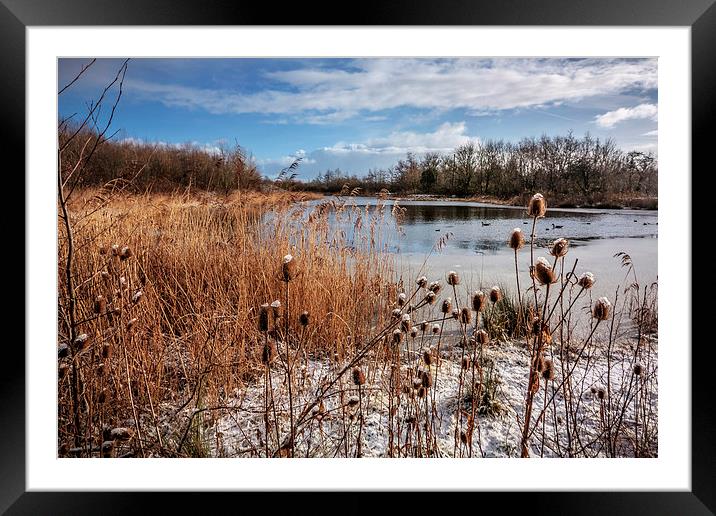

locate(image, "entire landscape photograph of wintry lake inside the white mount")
[[56, 55, 660, 461]]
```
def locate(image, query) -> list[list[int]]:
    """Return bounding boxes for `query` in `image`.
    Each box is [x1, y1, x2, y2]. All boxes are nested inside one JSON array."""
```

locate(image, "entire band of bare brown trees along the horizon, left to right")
[[59, 126, 658, 207]]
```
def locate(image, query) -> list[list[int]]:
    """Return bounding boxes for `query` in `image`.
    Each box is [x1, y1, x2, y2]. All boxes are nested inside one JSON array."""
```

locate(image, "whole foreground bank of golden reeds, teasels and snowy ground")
[[58, 190, 658, 457]]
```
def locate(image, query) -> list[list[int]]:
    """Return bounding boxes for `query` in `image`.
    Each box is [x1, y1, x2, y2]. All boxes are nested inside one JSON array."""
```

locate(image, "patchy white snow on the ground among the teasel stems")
[[185, 328, 657, 457]]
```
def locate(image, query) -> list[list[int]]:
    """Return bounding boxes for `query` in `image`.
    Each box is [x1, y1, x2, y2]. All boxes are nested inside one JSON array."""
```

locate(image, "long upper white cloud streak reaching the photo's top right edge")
[[127, 59, 657, 124]]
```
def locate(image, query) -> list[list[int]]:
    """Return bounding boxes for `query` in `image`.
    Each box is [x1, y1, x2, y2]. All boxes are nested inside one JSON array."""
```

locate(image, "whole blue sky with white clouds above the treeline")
[[58, 58, 657, 180]]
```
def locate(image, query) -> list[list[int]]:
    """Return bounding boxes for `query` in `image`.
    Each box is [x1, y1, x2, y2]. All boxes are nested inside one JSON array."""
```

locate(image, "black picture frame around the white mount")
[[5, 0, 716, 514]]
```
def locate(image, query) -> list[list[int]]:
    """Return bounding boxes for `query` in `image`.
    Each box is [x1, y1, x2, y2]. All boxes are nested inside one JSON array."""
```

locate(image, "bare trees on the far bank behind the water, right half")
[[306, 134, 658, 207]]
